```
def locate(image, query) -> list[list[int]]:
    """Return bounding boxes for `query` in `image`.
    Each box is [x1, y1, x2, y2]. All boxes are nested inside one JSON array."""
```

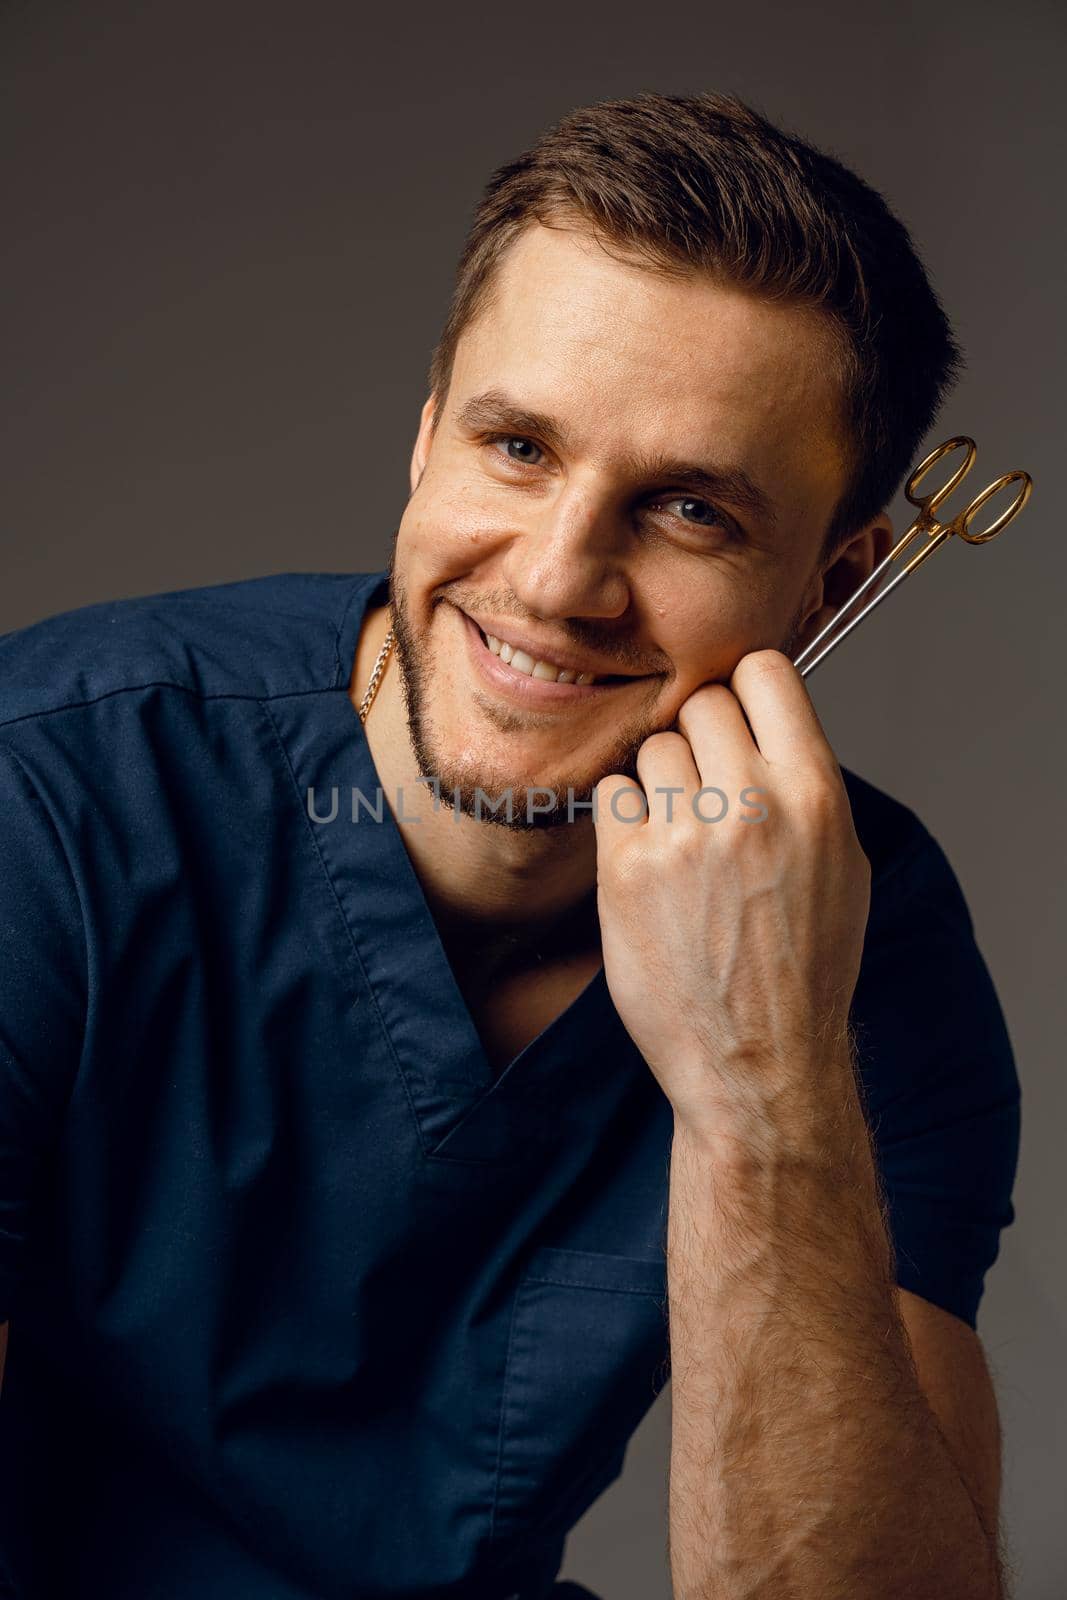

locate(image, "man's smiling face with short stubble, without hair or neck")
[[390, 224, 846, 826]]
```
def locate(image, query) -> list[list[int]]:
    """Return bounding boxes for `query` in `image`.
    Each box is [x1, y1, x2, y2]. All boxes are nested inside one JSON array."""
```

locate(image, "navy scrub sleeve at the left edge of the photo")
[[0, 744, 86, 1323]]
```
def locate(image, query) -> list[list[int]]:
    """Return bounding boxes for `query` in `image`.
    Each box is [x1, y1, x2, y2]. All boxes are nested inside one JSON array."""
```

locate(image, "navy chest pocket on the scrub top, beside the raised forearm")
[[493, 1246, 670, 1541]]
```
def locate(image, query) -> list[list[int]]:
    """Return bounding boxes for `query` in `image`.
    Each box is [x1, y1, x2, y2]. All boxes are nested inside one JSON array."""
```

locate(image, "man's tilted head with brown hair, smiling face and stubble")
[[392, 94, 958, 821]]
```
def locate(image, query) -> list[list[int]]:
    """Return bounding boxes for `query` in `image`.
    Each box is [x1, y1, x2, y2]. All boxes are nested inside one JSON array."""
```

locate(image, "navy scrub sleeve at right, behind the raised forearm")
[[853, 830, 1021, 1328]]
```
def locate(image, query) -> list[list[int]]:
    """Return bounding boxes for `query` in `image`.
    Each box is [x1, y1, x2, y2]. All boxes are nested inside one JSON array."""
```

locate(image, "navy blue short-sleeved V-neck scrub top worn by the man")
[[0, 571, 1019, 1600]]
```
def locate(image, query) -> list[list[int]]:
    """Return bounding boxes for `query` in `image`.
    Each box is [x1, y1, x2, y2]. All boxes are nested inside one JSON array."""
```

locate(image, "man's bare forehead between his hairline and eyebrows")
[[458, 226, 843, 469]]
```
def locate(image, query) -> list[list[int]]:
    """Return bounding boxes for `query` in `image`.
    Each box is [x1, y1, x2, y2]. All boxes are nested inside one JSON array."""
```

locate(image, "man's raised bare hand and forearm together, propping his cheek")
[[595, 650, 1001, 1600]]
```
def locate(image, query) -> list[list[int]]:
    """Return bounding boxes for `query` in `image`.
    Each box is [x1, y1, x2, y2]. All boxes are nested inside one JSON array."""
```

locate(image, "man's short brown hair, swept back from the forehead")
[[429, 93, 963, 562]]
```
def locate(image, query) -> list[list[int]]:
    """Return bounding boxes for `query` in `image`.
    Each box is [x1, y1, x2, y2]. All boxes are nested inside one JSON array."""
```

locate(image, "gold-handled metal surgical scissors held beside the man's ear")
[[793, 435, 1033, 678]]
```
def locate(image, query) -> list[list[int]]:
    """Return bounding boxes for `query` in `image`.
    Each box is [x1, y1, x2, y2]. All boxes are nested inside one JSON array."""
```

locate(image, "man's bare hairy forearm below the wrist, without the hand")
[[667, 1059, 1000, 1600]]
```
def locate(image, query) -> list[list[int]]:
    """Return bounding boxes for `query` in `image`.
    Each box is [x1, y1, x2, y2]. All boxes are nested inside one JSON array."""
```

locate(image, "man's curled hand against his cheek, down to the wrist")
[[595, 650, 870, 1149]]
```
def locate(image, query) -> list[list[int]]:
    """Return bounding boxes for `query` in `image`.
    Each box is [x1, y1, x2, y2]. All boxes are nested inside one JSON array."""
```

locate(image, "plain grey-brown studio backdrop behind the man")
[[0, 0, 1067, 1600]]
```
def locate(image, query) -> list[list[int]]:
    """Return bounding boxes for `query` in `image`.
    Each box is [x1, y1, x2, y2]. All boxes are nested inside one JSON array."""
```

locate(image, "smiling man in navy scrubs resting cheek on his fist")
[[0, 94, 1019, 1600]]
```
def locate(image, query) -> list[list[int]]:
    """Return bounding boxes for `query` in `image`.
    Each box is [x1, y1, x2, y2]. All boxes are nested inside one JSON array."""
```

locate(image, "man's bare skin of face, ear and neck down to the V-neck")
[[354, 214, 870, 1066]]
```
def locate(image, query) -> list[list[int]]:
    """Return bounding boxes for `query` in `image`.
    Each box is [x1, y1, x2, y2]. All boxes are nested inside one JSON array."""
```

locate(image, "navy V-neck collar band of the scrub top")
[[272, 571, 648, 1160]]
